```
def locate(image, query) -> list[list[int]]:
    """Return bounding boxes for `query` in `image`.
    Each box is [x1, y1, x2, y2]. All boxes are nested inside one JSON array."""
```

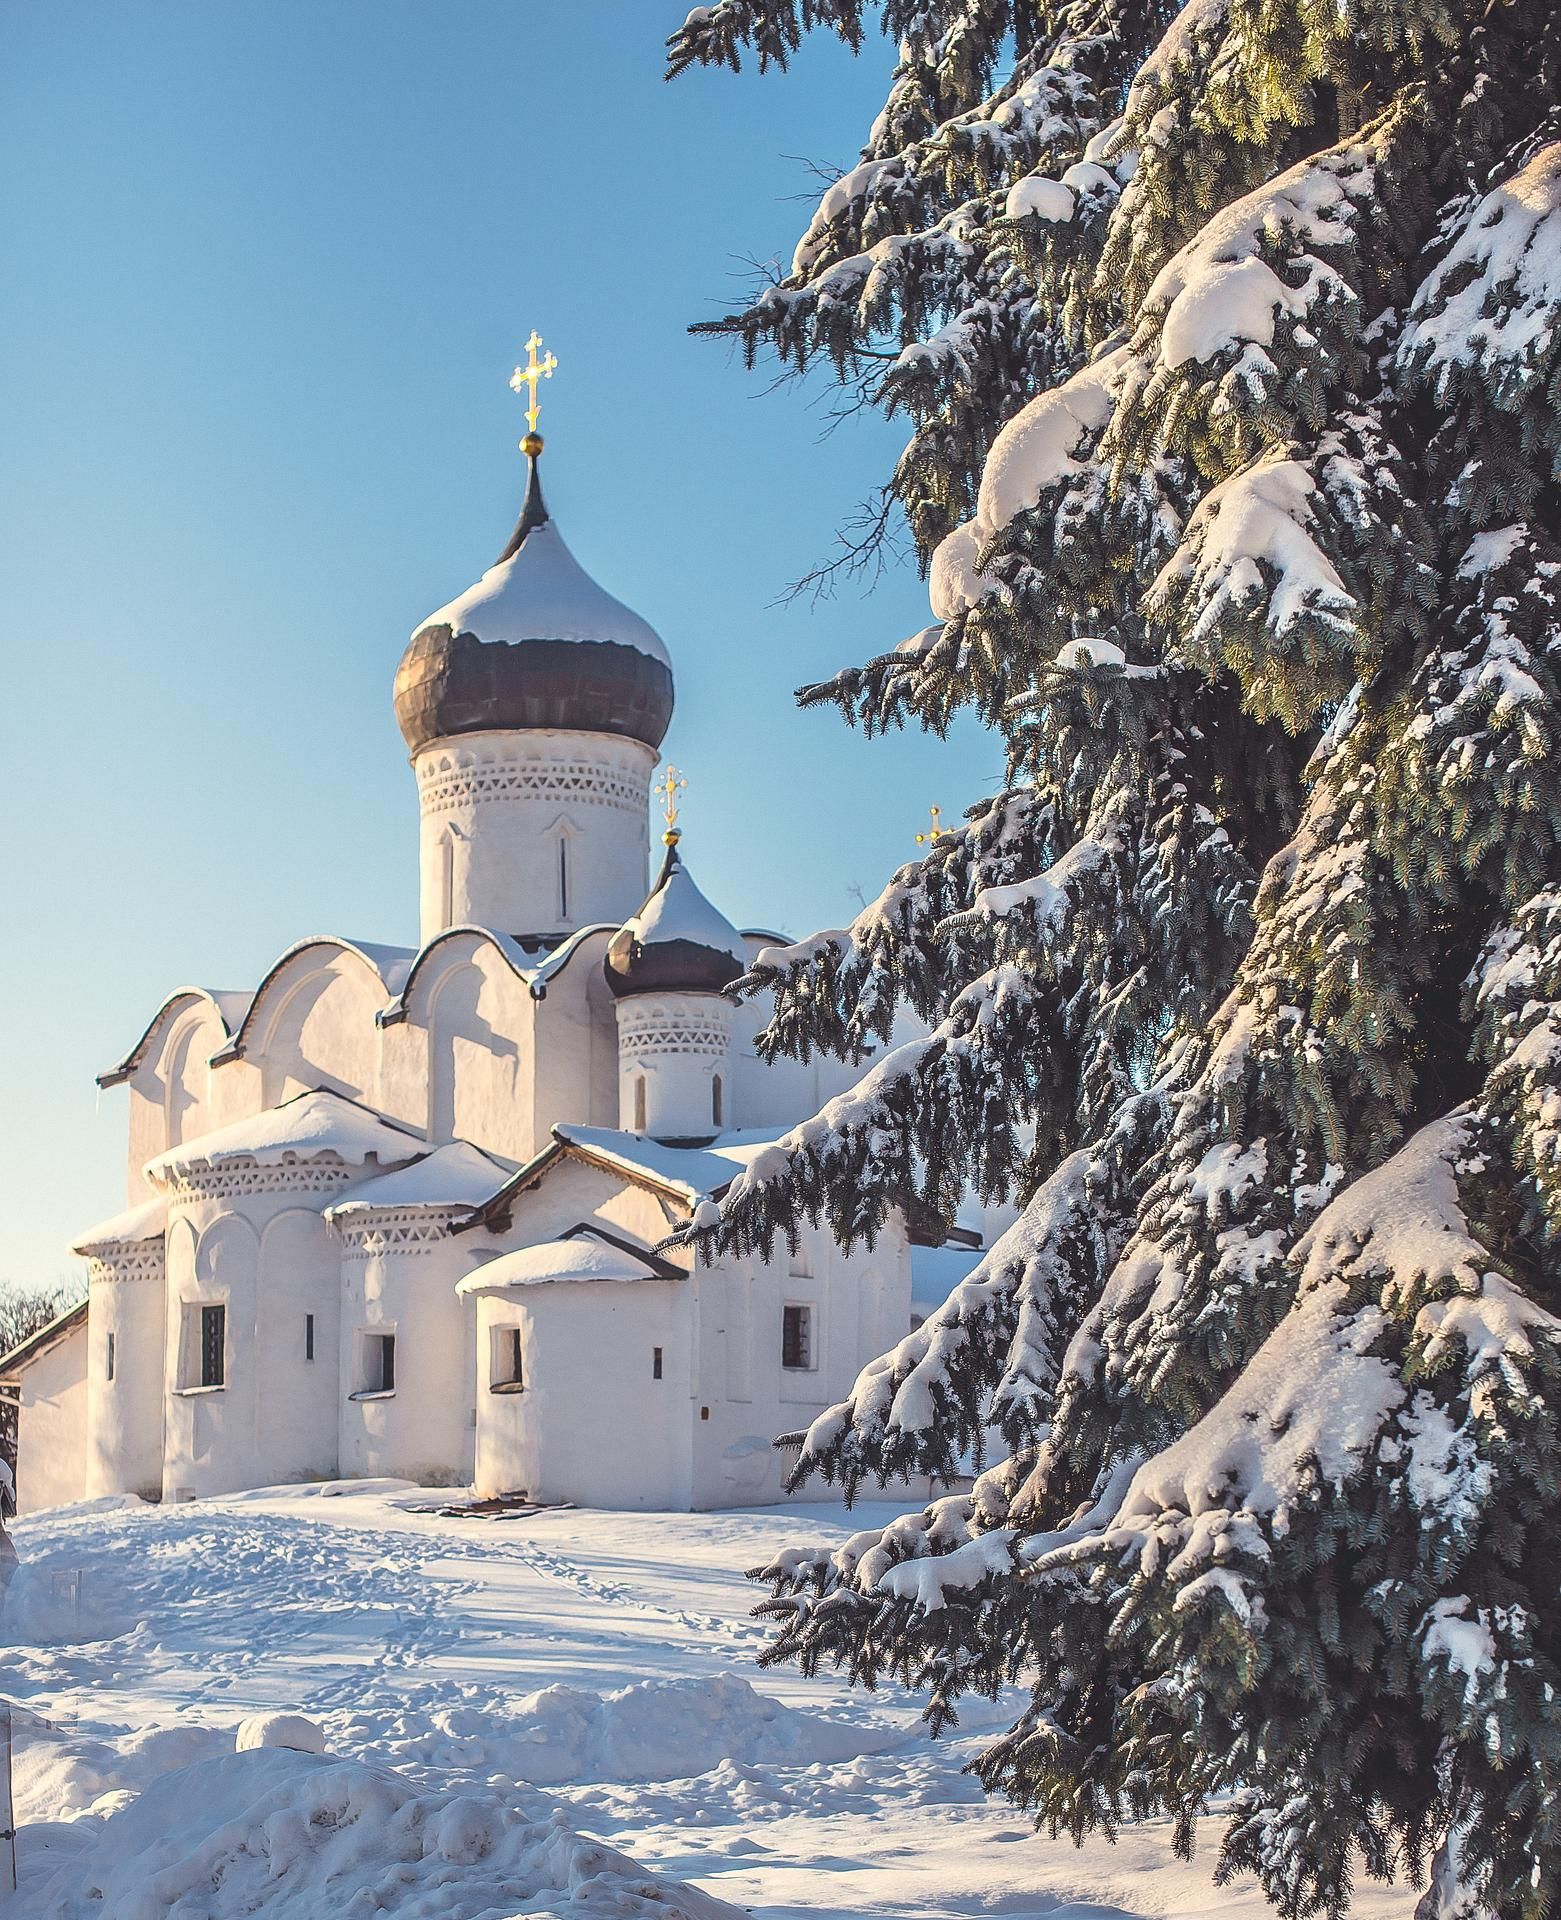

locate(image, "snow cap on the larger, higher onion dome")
[[417, 520, 672, 670]]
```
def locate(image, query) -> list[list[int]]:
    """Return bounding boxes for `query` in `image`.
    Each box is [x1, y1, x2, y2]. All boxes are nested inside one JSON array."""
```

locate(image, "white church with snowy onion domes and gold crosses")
[[0, 349, 970, 1509]]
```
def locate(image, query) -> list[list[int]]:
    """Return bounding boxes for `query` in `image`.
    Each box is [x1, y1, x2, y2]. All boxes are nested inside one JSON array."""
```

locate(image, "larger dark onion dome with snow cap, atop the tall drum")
[[396, 440, 672, 753]]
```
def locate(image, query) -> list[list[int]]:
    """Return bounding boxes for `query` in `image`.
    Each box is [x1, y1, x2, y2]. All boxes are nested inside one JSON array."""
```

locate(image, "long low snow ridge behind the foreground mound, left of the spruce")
[[328, 1674, 902, 1788]]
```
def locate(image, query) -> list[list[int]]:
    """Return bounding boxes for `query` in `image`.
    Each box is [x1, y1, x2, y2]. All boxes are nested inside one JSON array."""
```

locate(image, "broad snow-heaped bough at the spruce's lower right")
[[1037, 1110, 1561, 1615]]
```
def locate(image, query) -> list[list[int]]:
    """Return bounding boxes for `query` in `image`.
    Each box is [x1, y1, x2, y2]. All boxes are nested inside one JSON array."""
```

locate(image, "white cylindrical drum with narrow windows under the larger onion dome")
[[413, 728, 657, 941]]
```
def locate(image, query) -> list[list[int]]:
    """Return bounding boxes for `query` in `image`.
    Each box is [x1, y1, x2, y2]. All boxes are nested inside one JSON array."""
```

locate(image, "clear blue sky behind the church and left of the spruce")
[[0, 0, 997, 1284]]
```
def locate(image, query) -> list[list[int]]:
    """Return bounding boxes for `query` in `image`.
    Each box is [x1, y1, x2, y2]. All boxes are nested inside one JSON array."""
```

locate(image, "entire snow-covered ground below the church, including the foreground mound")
[[0, 1484, 1413, 1920]]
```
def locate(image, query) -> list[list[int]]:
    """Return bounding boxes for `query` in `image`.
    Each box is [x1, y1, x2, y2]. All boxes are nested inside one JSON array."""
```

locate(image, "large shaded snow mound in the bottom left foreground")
[[33, 1747, 737, 1920]]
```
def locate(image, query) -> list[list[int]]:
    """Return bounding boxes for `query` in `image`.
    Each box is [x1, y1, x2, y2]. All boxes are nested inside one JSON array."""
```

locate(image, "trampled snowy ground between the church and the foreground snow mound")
[[0, 1490, 1413, 1920]]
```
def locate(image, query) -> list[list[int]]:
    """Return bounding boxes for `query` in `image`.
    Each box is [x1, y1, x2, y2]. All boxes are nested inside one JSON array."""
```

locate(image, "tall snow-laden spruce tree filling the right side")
[[672, 0, 1561, 1916]]
